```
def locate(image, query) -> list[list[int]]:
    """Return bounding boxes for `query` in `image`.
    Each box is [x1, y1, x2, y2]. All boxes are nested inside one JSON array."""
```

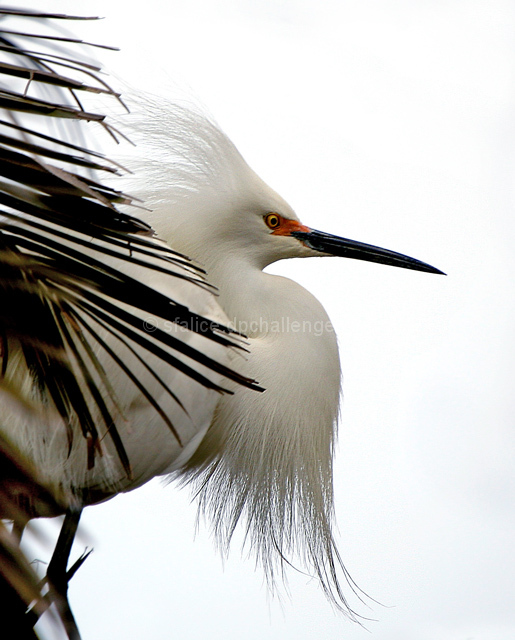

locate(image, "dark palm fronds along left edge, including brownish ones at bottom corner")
[[0, 7, 266, 638]]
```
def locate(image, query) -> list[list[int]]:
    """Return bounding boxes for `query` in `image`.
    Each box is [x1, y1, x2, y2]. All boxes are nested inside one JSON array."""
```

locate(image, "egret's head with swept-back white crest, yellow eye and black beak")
[[129, 102, 442, 273]]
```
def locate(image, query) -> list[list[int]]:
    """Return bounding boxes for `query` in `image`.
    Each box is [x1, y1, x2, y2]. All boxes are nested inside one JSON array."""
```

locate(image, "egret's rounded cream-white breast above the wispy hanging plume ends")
[[185, 276, 340, 468]]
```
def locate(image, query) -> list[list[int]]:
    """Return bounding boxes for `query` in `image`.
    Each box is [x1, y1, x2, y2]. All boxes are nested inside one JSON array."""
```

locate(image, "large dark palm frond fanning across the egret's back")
[[0, 9, 264, 475]]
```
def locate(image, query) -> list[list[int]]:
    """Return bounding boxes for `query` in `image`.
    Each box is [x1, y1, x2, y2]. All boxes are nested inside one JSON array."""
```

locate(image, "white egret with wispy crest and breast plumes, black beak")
[[6, 95, 444, 602]]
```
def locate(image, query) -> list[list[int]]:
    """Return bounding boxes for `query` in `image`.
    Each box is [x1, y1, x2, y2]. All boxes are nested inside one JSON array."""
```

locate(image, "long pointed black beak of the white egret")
[[291, 230, 445, 275]]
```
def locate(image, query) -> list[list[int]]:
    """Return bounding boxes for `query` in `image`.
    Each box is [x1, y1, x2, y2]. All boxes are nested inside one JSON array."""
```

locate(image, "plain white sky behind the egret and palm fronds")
[[27, 0, 515, 640]]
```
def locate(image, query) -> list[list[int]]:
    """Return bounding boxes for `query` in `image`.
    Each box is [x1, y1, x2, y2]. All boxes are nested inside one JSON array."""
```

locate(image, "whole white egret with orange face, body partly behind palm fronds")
[[2, 8, 441, 636]]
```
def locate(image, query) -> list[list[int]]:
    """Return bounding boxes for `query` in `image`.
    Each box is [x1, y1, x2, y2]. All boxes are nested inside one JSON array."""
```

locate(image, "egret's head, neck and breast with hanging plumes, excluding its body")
[[112, 100, 442, 616]]
